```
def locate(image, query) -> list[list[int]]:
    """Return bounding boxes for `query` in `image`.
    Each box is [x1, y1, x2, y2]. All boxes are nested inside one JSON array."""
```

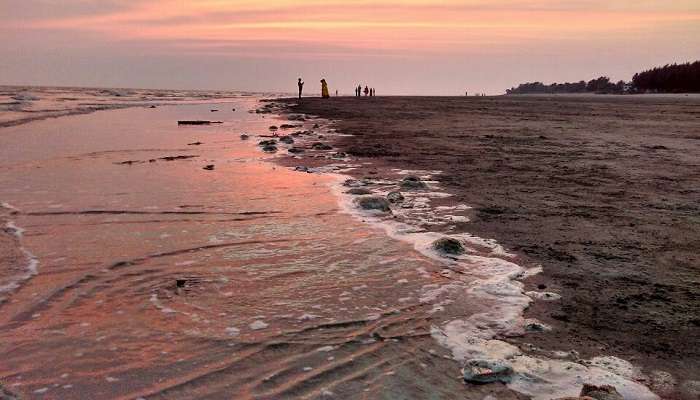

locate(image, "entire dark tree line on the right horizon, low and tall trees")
[[506, 61, 700, 94]]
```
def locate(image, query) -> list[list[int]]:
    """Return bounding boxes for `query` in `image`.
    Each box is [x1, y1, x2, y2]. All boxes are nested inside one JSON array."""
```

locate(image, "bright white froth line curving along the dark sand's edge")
[[320, 171, 658, 400]]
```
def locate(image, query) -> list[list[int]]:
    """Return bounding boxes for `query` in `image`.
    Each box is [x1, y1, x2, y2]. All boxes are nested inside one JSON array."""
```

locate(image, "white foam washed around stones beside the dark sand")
[[292, 111, 658, 400]]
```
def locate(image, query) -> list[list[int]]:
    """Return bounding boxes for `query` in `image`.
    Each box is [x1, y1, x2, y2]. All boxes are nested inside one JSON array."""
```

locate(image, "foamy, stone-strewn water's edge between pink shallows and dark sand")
[[263, 102, 657, 400]]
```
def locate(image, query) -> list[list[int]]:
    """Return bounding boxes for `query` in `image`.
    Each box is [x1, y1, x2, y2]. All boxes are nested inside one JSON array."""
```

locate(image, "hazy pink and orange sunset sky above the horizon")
[[0, 0, 700, 95]]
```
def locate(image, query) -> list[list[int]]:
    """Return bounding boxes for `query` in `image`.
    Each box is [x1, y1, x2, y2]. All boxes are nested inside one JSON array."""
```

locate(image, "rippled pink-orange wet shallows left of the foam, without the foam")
[[0, 97, 523, 400]]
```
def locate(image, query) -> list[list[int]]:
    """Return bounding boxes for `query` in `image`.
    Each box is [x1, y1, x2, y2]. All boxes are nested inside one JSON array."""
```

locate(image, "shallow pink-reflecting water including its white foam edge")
[[0, 94, 653, 399]]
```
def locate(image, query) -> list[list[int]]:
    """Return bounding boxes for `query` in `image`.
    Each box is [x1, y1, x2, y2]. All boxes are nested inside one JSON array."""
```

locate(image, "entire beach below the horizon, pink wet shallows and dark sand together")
[[0, 88, 698, 400]]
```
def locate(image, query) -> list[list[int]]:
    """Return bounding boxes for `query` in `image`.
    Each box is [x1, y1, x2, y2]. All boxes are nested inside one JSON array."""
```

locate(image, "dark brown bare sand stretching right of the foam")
[[288, 96, 700, 398]]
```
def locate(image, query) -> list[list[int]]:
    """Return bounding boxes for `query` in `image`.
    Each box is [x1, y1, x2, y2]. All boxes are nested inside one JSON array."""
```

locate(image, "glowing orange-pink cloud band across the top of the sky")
[[9, 0, 700, 51]]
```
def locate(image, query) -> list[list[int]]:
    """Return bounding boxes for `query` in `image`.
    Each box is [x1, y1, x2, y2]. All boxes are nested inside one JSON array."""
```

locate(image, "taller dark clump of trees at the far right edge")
[[632, 61, 700, 93]]
